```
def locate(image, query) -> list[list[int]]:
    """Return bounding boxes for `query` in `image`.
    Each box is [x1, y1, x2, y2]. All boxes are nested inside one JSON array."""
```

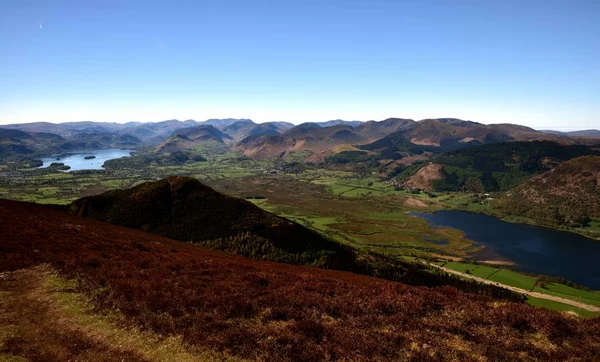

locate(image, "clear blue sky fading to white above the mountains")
[[0, 0, 600, 130]]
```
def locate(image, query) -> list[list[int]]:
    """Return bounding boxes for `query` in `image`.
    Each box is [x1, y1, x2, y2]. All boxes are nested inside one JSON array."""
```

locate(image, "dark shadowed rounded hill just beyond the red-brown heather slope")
[[69, 177, 335, 250]]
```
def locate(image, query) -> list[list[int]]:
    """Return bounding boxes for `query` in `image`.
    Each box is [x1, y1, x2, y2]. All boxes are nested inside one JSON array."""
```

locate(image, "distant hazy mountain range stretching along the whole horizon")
[[0, 118, 600, 162]]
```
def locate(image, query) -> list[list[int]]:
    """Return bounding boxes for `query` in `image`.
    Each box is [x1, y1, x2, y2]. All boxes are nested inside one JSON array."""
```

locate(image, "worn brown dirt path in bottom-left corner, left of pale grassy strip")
[[0, 266, 147, 361]]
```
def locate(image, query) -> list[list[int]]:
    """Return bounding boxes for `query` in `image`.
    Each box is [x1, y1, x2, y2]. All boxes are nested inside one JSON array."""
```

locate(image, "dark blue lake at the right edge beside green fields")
[[411, 210, 600, 289]]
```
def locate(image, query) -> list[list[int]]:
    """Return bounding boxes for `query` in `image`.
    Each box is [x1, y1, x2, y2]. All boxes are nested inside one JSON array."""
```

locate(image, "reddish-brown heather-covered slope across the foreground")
[[0, 200, 600, 361]]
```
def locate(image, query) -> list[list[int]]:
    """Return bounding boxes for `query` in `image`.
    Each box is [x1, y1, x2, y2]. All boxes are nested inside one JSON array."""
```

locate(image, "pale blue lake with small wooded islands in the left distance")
[[40, 148, 135, 171]]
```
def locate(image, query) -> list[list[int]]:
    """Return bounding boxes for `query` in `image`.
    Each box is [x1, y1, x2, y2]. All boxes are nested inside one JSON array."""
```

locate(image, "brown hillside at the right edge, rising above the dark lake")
[[502, 156, 600, 227]]
